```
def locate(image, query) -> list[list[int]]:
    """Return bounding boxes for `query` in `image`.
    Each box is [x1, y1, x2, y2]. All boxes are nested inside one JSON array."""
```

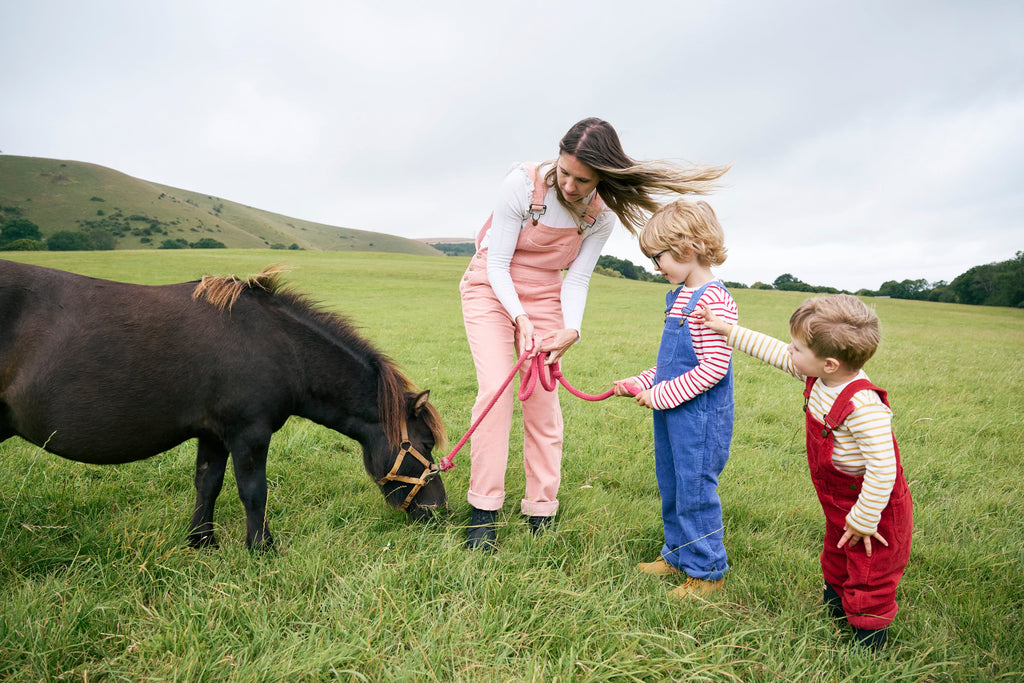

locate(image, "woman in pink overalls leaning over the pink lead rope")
[[459, 118, 727, 550]]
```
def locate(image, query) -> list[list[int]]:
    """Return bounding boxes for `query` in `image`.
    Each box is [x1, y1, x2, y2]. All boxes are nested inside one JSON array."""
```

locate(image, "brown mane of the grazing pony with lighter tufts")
[[193, 265, 446, 449]]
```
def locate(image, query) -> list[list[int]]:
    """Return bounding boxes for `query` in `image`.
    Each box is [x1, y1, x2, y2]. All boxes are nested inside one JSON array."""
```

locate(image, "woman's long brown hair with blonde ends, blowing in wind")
[[543, 117, 729, 236]]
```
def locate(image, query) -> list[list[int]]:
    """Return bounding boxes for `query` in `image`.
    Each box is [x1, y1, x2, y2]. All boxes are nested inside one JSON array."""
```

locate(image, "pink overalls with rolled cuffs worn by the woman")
[[459, 165, 603, 517]]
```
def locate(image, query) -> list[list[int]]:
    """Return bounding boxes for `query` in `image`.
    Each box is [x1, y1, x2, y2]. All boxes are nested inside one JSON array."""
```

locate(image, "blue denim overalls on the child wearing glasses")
[[654, 282, 732, 581]]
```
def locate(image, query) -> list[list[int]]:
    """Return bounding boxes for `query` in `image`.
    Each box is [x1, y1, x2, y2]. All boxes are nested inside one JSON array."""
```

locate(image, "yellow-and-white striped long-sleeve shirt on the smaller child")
[[727, 325, 896, 536]]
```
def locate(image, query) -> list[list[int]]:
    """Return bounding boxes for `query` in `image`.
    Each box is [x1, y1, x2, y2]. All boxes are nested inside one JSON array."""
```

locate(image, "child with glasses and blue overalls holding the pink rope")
[[614, 200, 737, 597]]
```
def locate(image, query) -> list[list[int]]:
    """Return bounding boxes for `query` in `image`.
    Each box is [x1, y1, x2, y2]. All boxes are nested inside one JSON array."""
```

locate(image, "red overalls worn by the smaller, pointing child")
[[804, 377, 913, 630]]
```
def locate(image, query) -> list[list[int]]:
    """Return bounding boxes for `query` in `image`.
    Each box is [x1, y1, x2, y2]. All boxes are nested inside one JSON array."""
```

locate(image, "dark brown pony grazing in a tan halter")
[[0, 260, 447, 549]]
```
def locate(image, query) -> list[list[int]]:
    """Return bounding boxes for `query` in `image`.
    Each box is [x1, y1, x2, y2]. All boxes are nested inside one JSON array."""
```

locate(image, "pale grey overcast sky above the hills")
[[0, 0, 1024, 290]]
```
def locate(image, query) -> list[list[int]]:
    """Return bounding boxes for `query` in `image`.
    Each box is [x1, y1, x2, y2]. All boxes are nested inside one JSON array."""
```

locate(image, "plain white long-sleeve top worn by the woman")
[[480, 164, 618, 333]]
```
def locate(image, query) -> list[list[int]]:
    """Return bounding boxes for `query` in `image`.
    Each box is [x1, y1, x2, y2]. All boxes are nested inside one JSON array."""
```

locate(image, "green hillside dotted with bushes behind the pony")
[[0, 155, 440, 256]]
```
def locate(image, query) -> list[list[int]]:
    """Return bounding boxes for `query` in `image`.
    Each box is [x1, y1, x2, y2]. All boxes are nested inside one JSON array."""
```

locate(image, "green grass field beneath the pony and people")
[[0, 250, 1024, 682]]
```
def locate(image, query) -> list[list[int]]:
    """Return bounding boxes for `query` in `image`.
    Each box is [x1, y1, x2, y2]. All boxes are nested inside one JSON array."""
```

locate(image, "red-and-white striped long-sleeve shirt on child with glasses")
[[631, 287, 738, 411]]
